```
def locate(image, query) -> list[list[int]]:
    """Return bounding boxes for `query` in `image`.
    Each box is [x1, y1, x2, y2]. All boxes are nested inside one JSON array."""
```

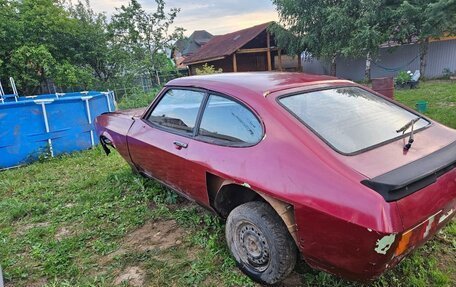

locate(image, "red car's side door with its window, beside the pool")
[[128, 88, 206, 194]]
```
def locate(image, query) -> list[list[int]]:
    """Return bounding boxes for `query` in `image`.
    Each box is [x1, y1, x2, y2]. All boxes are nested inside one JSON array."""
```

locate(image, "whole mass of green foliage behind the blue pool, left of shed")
[[0, 0, 183, 95]]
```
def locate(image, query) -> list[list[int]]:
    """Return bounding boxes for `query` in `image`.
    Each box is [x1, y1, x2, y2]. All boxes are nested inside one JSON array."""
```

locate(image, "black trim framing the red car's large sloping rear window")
[[275, 85, 433, 156]]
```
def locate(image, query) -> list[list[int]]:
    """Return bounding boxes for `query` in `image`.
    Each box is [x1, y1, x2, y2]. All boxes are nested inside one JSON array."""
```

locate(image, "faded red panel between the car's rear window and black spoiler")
[[337, 122, 456, 178]]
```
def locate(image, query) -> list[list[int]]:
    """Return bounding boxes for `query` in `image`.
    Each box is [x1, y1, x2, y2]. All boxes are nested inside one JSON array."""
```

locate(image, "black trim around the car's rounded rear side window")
[[194, 90, 266, 148]]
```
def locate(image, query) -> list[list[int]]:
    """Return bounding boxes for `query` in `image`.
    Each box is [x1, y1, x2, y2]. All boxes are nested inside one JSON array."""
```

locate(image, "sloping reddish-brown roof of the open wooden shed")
[[184, 22, 272, 65]]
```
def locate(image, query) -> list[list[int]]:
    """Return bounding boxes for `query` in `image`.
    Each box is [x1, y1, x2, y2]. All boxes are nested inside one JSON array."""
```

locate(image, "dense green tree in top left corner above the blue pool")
[[0, 0, 85, 94]]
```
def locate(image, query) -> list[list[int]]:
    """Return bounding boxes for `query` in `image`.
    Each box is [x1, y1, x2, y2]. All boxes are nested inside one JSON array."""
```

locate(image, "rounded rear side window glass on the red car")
[[198, 95, 263, 145]]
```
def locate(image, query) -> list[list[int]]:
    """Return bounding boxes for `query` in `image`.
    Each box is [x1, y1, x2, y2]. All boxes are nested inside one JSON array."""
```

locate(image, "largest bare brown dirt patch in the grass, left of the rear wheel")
[[99, 220, 186, 265]]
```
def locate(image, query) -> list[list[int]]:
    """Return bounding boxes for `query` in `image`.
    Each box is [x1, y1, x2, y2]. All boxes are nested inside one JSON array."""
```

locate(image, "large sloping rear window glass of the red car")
[[279, 87, 430, 154]]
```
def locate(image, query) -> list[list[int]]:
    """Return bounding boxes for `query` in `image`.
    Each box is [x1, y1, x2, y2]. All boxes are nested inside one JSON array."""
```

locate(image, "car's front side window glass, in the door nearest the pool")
[[147, 89, 205, 134]]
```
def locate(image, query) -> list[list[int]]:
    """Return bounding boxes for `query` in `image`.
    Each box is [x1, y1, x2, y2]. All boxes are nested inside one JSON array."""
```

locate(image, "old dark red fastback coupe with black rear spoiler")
[[96, 73, 456, 284]]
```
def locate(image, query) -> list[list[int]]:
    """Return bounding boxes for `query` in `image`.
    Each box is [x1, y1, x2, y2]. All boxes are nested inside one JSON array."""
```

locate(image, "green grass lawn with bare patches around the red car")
[[0, 82, 456, 286]]
